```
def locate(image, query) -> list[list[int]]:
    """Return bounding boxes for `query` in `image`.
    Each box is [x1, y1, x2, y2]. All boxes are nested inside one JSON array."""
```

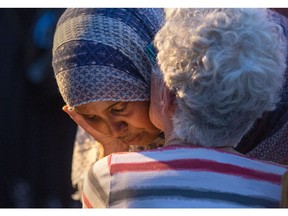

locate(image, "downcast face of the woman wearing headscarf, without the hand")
[[75, 101, 160, 145]]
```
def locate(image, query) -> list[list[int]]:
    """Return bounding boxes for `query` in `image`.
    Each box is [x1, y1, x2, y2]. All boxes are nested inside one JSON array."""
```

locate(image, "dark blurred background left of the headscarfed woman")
[[0, 8, 80, 208]]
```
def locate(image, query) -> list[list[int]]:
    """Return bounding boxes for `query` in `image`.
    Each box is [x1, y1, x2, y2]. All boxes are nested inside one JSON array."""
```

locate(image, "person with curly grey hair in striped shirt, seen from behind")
[[83, 8, 288, 208]]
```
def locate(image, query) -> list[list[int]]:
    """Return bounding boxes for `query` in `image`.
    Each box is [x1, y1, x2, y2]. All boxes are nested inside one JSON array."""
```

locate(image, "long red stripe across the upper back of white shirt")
[[111, 159, 281, 184]]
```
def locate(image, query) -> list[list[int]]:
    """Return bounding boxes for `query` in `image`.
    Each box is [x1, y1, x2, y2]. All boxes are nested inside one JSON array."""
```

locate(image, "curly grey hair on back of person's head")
[[155, 8, 286, 147]]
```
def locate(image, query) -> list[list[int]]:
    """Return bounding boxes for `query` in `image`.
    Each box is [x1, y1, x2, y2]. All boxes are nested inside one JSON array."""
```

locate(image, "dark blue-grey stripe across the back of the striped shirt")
[[109, 187, 279, 208]]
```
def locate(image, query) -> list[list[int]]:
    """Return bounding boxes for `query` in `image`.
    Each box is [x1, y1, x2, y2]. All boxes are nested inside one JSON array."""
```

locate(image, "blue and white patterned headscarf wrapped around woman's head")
[[52, 8, 164, 107]]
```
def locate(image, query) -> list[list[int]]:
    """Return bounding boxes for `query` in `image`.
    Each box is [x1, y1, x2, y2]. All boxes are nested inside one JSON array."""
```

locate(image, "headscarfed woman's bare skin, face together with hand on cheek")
[[63, 101, 160, 155]]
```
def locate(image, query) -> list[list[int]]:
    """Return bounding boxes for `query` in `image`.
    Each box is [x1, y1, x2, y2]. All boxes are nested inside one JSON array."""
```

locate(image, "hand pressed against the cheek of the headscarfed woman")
[[62, 105, 130, 156]]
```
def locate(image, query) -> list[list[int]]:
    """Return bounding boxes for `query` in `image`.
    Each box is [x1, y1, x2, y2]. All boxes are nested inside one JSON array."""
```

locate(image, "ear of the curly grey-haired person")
[[162, 86, 176, 116]]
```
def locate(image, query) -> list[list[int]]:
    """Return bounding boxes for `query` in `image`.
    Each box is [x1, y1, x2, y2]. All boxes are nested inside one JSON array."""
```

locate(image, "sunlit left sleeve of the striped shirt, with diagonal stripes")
[[82, 155, 111, 208]]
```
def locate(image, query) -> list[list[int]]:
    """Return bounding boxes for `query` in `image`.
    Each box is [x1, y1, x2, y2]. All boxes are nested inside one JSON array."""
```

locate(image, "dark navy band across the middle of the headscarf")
[[53, 40, 149, 85]]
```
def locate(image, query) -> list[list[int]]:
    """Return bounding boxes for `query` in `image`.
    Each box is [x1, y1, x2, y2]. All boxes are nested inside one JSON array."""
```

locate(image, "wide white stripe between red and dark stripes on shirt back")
[[111, 171, 281, 200]]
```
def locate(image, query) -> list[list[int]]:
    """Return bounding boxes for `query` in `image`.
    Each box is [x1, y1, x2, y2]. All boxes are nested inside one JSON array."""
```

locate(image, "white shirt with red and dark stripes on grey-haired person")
[[83, 145, 288, 208]]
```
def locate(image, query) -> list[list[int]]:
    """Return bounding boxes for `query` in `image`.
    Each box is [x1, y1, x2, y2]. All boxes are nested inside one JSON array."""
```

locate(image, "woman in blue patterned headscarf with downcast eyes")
[[53, 8, 163, 199]]
